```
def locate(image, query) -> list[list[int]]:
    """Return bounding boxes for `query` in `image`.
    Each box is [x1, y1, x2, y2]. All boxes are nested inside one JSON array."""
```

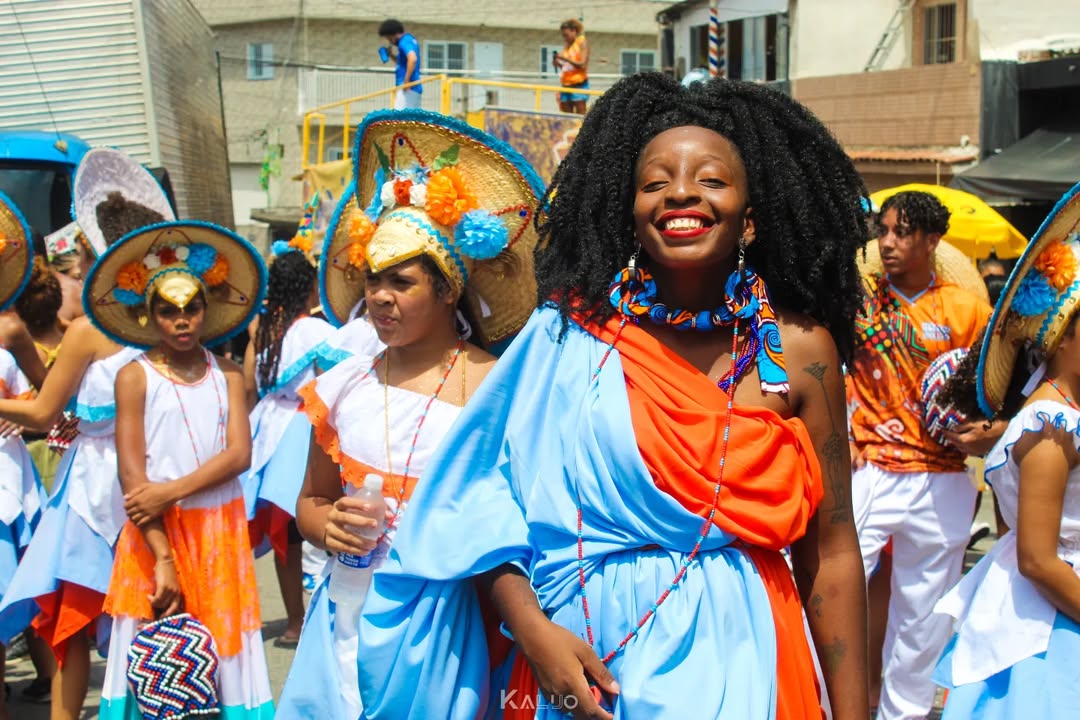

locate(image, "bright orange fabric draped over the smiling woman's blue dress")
[[586, 317, 823, 720]]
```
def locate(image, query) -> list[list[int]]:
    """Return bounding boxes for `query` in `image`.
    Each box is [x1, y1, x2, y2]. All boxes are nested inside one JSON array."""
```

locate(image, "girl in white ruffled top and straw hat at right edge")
[[935, 185, 1080, 720]]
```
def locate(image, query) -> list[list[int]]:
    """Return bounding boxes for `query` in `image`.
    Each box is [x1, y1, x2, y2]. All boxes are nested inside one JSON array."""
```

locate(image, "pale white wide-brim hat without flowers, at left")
[[71, 148, 176, 257]]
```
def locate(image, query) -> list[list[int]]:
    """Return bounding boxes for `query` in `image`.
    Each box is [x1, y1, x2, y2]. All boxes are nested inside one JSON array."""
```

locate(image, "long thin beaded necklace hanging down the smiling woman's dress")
[[577, 316, 739, 665]]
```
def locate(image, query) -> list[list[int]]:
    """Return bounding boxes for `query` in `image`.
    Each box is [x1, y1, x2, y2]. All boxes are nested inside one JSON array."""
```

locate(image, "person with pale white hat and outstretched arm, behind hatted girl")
[[0, 148, 173, 720]]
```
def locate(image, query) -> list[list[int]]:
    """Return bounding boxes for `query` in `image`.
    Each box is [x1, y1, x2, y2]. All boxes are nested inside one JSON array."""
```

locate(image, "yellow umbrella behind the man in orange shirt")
[[870, 182, 1027, 259]]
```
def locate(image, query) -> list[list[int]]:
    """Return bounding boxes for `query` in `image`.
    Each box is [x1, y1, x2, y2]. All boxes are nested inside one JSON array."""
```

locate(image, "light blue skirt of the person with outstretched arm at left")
[[0, 445, 112, 644]]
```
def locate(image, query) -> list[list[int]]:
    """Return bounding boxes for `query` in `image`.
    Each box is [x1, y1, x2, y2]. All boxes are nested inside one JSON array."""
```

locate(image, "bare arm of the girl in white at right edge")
[[1015, 429, 1080, 622]]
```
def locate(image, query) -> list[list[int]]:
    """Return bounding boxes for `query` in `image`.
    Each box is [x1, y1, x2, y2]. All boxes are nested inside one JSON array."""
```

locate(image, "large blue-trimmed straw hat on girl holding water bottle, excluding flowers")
[[320, 110, 543, 343]]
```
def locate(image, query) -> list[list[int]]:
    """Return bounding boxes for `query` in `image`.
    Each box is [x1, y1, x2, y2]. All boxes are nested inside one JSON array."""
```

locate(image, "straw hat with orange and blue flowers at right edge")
[[975, 184, 1080, 417]]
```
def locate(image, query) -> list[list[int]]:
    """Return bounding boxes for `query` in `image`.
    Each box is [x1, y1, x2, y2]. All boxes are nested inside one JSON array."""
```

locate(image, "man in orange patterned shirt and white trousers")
[[848, 192, 1001, 720]]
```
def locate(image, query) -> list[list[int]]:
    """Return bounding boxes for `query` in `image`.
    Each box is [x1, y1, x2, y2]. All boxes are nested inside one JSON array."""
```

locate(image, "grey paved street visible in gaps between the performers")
[[8, 493, 994, 720]]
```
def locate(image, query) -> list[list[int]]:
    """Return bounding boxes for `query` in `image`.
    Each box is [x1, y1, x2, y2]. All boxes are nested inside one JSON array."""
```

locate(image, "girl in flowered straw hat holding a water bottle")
[[278, 111, 540, 720]]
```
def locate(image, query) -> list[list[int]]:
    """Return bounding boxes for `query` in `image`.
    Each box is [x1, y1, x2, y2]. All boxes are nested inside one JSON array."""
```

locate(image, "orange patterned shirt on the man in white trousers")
[[848, 275, 991, 473]]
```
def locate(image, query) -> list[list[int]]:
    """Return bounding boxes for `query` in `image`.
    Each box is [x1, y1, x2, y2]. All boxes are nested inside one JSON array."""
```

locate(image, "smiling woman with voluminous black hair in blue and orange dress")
[[361, 73, 867, 720]]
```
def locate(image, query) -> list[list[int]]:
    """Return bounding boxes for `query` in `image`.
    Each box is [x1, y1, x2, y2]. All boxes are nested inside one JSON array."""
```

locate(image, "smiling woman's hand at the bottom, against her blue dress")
[[514, 617, 619, 720]]
